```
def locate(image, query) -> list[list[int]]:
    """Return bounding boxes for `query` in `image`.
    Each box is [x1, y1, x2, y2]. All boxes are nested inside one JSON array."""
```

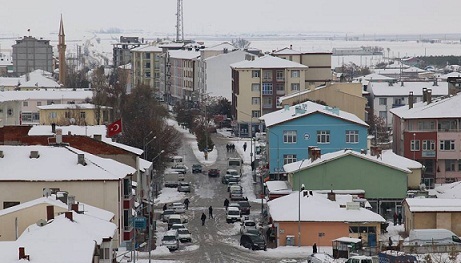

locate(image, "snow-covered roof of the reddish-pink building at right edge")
[[390, 93, 461, 119]]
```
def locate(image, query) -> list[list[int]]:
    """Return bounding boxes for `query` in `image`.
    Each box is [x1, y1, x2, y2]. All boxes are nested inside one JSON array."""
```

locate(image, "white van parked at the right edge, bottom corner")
[[405, 229, 461, 248]]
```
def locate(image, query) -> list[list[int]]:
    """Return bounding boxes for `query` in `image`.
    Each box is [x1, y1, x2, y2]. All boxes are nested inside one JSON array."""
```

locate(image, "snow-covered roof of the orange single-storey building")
[[267, 192, 386, 222]]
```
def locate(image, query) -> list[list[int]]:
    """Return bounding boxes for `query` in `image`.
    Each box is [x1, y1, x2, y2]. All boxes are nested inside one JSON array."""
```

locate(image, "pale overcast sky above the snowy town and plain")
[[0, 0, 461, 38]]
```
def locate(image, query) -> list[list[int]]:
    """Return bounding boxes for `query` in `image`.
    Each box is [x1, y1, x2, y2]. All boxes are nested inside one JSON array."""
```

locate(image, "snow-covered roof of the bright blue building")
[[259, 101, 368, 127]]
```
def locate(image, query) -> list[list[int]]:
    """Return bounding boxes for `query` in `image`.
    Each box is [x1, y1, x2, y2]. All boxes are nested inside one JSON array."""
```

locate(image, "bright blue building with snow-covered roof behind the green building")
[[260, 101, 368, 179]]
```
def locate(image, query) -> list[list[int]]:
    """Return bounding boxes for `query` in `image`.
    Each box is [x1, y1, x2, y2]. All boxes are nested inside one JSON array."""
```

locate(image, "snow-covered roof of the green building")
[[283, 150, 422, 173]]
